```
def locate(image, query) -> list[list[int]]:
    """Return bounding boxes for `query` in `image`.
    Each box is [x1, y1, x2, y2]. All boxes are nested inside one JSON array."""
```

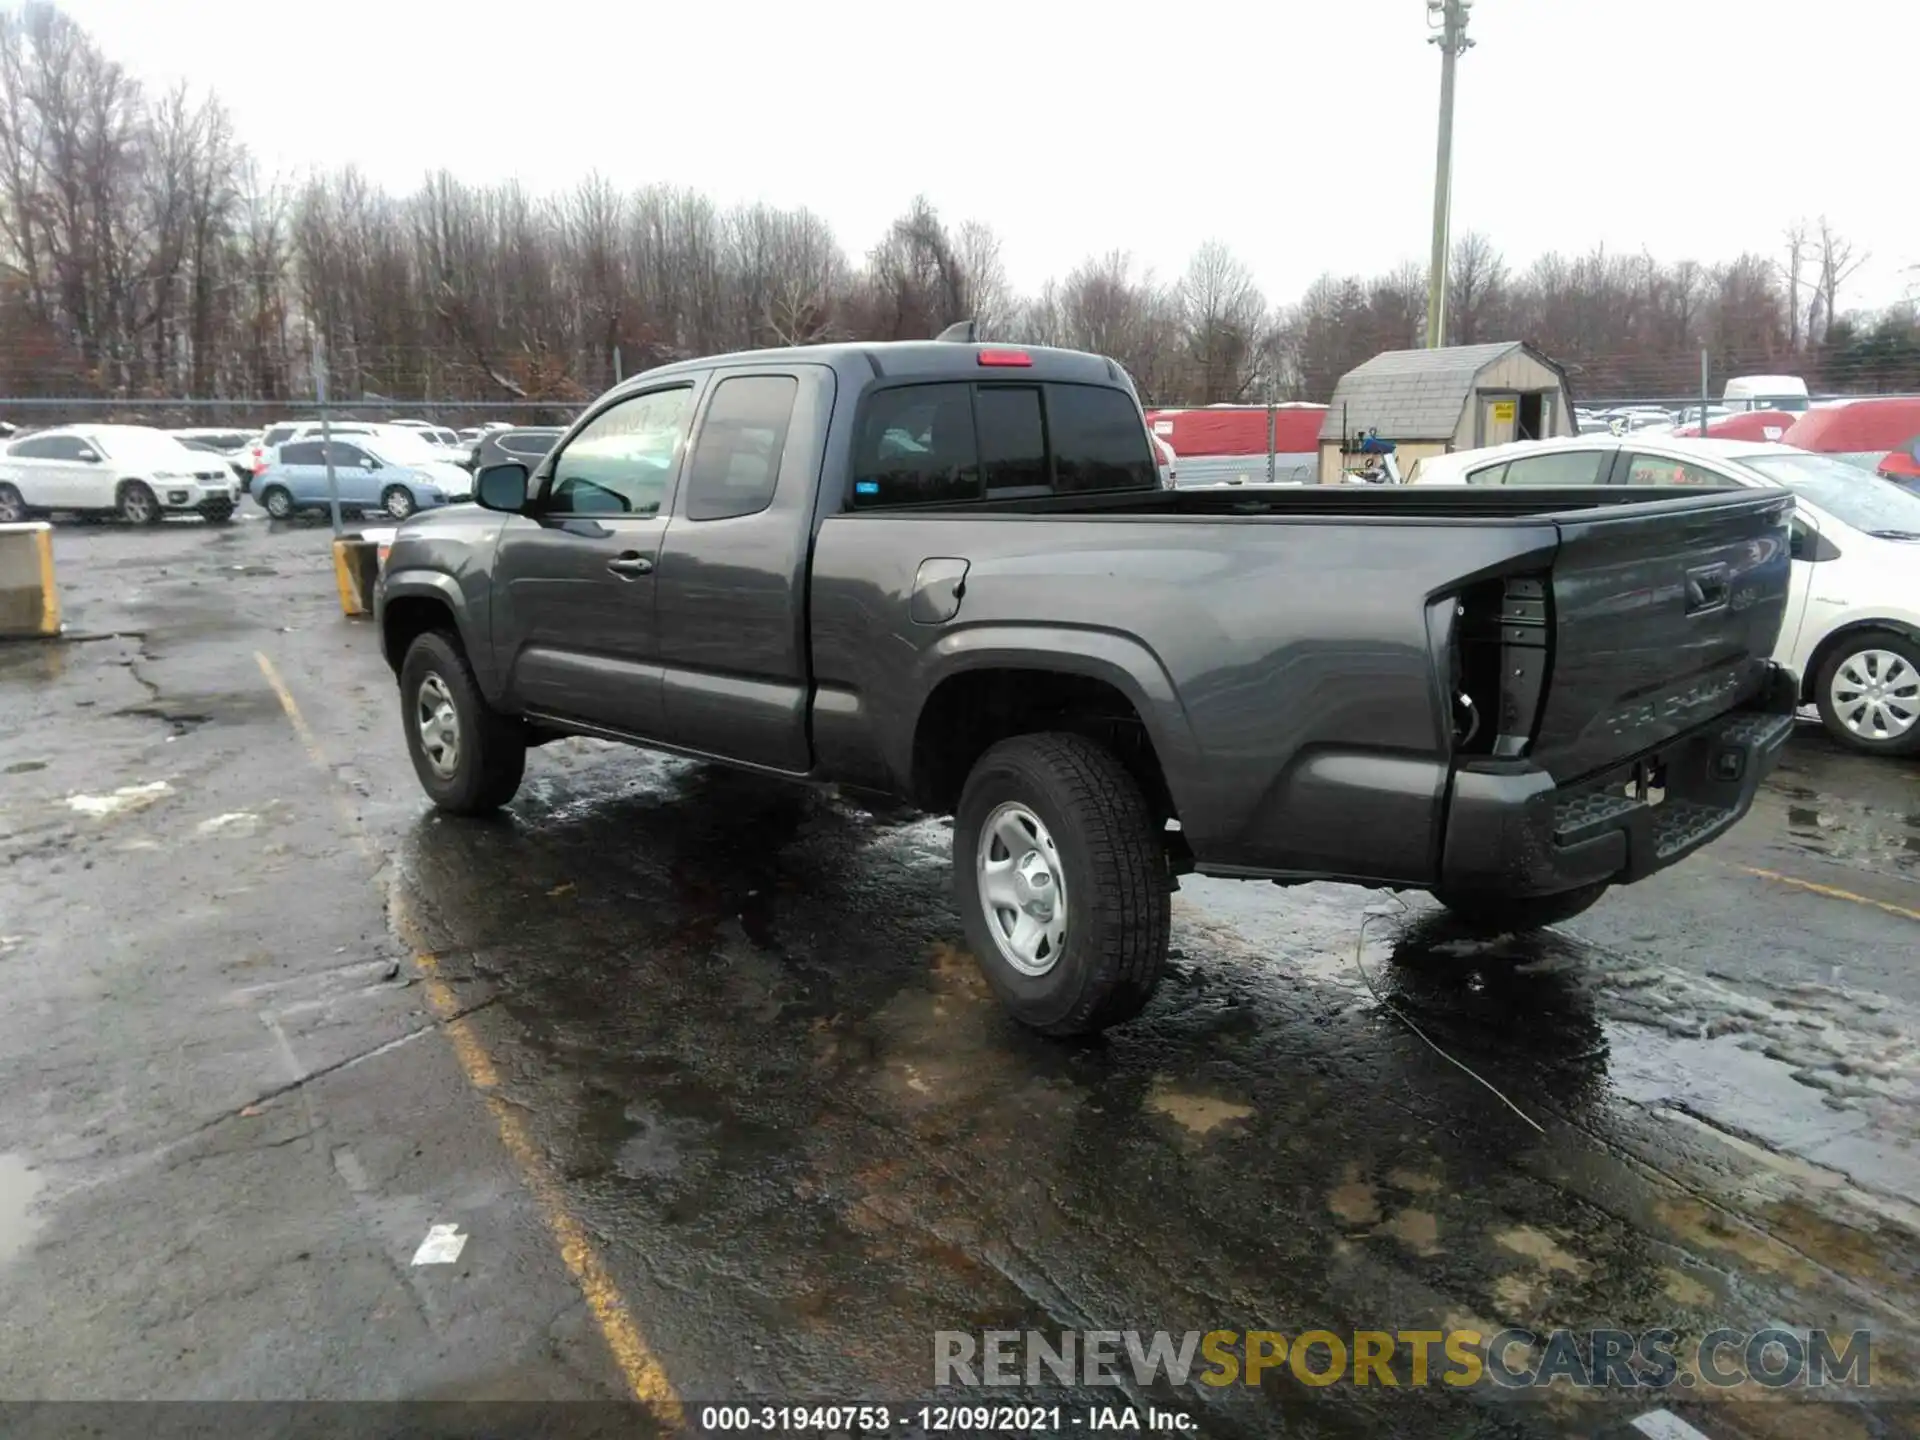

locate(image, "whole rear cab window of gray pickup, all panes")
[[849, 380, 1160, 509]]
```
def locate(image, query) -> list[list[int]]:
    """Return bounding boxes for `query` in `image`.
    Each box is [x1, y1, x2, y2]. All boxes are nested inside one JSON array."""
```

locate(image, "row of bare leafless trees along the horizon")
[[0, 4, 1920, 416]]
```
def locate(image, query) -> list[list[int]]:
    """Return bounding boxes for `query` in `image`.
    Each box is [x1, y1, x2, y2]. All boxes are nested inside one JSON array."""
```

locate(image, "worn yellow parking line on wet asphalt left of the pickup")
[[253, 651, 685, 1430]]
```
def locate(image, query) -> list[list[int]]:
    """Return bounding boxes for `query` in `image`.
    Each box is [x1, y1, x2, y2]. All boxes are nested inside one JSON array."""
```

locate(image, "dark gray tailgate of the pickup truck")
[[1532, 490, 1793, 783]]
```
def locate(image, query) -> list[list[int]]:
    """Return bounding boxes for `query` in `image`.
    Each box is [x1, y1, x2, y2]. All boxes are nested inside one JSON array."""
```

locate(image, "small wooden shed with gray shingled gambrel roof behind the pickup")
[[1319, 340, 1576, 486]]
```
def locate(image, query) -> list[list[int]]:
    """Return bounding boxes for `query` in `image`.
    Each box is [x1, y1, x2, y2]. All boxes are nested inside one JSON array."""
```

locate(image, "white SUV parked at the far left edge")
[[0, 424, 240, 524]]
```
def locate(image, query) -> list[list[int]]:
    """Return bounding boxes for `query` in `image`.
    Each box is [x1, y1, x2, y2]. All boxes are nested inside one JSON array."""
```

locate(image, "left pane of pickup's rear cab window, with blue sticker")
[[852, 384, 981, 509]]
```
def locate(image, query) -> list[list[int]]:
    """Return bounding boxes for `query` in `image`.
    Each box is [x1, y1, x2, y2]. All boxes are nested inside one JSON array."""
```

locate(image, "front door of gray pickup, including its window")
[[493, 378, 697, 739]]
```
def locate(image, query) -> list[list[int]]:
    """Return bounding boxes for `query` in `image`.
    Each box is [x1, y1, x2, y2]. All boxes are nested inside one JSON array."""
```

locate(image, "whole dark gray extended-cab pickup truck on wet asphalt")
[[376, 340, 1797, 1035]]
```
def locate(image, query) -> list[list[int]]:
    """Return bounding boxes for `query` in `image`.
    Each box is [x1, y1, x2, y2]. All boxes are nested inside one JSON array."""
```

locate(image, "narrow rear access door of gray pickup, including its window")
[[655, 365, 833, 774]]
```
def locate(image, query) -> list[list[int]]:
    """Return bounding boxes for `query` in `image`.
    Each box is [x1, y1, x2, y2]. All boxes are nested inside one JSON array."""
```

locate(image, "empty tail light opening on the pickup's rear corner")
[[1448, 574, 1553, 760]]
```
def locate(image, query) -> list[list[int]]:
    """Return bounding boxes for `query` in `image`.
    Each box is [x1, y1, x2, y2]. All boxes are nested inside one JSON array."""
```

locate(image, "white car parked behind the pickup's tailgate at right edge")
[[1413, 436, 1920, 755]]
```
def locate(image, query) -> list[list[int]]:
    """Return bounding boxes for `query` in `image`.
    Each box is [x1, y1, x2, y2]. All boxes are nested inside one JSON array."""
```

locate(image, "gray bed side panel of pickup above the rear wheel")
[[812, 513, 1555, 881]]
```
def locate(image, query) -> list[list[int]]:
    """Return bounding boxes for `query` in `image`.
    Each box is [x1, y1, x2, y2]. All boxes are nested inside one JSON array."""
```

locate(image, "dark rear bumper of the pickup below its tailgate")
[[1440, 664, 1799, 897]]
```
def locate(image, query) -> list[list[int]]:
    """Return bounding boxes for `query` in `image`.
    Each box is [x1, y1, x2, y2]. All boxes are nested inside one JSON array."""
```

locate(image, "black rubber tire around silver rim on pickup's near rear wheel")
[[952, 733, 1173, 1035]]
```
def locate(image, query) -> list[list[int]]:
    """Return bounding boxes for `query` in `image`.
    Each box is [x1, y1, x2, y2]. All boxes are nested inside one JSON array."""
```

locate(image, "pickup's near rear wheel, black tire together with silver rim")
[[952, 733, 1173, 1035]]
